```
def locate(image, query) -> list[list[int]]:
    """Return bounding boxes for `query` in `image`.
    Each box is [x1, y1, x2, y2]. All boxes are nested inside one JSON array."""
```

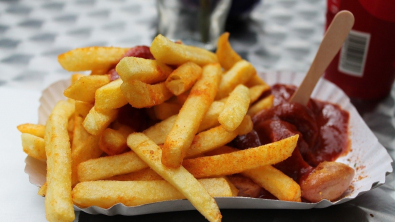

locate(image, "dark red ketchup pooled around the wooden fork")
[[232, 84, 349, 190]]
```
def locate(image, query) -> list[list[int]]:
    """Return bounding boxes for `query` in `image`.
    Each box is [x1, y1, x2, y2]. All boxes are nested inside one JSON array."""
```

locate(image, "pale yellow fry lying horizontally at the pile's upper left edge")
[[58, 47, 129, 71]]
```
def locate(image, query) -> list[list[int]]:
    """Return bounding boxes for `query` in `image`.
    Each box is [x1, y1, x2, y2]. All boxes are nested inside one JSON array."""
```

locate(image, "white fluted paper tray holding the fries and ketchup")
[[25, 72, 392, 215]]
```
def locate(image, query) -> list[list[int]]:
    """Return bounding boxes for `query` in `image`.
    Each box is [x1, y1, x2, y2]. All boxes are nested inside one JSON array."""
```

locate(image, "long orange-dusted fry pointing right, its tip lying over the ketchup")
[[183, 135, 298, 178]]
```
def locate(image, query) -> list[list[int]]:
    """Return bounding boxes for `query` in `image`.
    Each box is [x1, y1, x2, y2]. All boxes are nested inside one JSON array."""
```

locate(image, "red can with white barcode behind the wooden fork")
[[325, 0, 395, 100]]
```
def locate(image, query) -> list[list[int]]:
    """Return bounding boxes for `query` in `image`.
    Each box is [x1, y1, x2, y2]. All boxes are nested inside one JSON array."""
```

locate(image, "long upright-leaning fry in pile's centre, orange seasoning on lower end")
[[162, 63, 221, 168]]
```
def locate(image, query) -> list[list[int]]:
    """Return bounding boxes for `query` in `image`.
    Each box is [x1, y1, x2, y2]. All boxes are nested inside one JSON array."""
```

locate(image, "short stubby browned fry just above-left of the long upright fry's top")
[[166, 62, 202, 96]]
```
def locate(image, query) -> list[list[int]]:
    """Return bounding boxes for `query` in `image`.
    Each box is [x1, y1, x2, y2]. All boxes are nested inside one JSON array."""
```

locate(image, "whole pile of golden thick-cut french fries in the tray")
[[18, 33, 301, 221]]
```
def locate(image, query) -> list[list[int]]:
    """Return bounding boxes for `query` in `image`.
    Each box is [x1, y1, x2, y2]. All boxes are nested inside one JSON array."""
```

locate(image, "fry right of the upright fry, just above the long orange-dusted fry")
[[186, 116, 252, 157]]
